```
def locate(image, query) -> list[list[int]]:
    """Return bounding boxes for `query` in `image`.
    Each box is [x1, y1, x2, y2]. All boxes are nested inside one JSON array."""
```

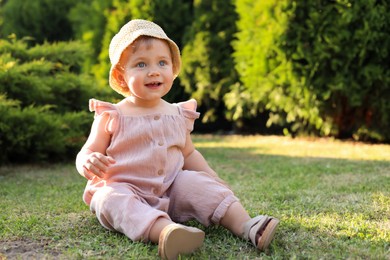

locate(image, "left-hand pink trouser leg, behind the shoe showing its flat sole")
[[90, 183, 169, 242]]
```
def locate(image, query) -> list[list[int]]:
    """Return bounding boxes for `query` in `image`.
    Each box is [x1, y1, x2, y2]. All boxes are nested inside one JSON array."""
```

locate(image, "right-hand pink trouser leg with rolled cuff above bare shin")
[[168, 171, 238, 226]]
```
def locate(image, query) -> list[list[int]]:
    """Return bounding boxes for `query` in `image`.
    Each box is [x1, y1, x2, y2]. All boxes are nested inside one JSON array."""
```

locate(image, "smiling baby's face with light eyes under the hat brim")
[[121, 38, 174, 105]]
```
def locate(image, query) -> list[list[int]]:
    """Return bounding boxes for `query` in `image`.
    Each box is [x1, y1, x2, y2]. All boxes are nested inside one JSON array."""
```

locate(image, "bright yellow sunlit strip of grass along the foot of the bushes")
[[195, 135, 390, 161]]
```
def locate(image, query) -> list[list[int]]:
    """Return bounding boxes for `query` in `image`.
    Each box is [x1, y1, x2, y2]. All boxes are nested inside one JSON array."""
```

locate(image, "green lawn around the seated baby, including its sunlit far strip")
[[0, 136, 390, 259]]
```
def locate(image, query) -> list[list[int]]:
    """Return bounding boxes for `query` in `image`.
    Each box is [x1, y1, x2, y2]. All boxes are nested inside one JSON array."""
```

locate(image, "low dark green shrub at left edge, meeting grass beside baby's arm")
[[0, 96, 91, 163]]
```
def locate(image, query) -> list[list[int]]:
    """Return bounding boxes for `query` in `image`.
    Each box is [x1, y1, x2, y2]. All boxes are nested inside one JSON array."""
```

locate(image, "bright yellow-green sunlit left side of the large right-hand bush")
[[225, 0, 295, 127]]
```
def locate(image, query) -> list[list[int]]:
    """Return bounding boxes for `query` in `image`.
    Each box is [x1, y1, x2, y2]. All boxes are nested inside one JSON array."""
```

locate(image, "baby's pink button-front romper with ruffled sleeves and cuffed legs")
[[84, 99, 238, 241]]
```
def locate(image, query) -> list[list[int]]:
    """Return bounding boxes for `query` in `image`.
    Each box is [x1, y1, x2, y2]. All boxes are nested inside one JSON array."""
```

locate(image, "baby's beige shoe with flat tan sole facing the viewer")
[[158, 224, 205, 260]]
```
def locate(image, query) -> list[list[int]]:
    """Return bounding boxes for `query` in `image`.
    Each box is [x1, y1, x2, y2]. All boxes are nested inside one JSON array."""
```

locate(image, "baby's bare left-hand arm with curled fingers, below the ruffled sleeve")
[[76, 112, 115, 180]]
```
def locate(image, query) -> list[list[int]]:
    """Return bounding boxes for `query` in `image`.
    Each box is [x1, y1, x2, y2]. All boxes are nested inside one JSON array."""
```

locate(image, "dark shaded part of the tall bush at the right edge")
[[285, 0, 390, 141]]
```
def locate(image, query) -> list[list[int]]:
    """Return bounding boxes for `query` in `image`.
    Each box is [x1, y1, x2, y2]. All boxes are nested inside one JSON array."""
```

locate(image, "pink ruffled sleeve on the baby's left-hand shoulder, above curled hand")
[[89, 99, 119, 134]]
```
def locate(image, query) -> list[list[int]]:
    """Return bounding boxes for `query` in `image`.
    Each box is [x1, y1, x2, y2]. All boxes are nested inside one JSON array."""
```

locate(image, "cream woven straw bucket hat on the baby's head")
[[109, 19, 181, 97]]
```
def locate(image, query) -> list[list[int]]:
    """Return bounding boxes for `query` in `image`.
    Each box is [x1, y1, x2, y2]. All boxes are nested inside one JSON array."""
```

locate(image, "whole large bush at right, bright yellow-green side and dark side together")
[[230, 0, 390, 141]]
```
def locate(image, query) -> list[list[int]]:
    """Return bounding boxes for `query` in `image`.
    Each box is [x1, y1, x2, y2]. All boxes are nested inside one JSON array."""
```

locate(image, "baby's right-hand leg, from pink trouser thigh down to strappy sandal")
[[170, 171, 279, 250]]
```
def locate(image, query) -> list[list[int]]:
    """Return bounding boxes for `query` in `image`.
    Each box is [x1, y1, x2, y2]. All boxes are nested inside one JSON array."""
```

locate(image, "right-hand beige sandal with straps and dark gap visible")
[[243, 216, 279, 251]]
